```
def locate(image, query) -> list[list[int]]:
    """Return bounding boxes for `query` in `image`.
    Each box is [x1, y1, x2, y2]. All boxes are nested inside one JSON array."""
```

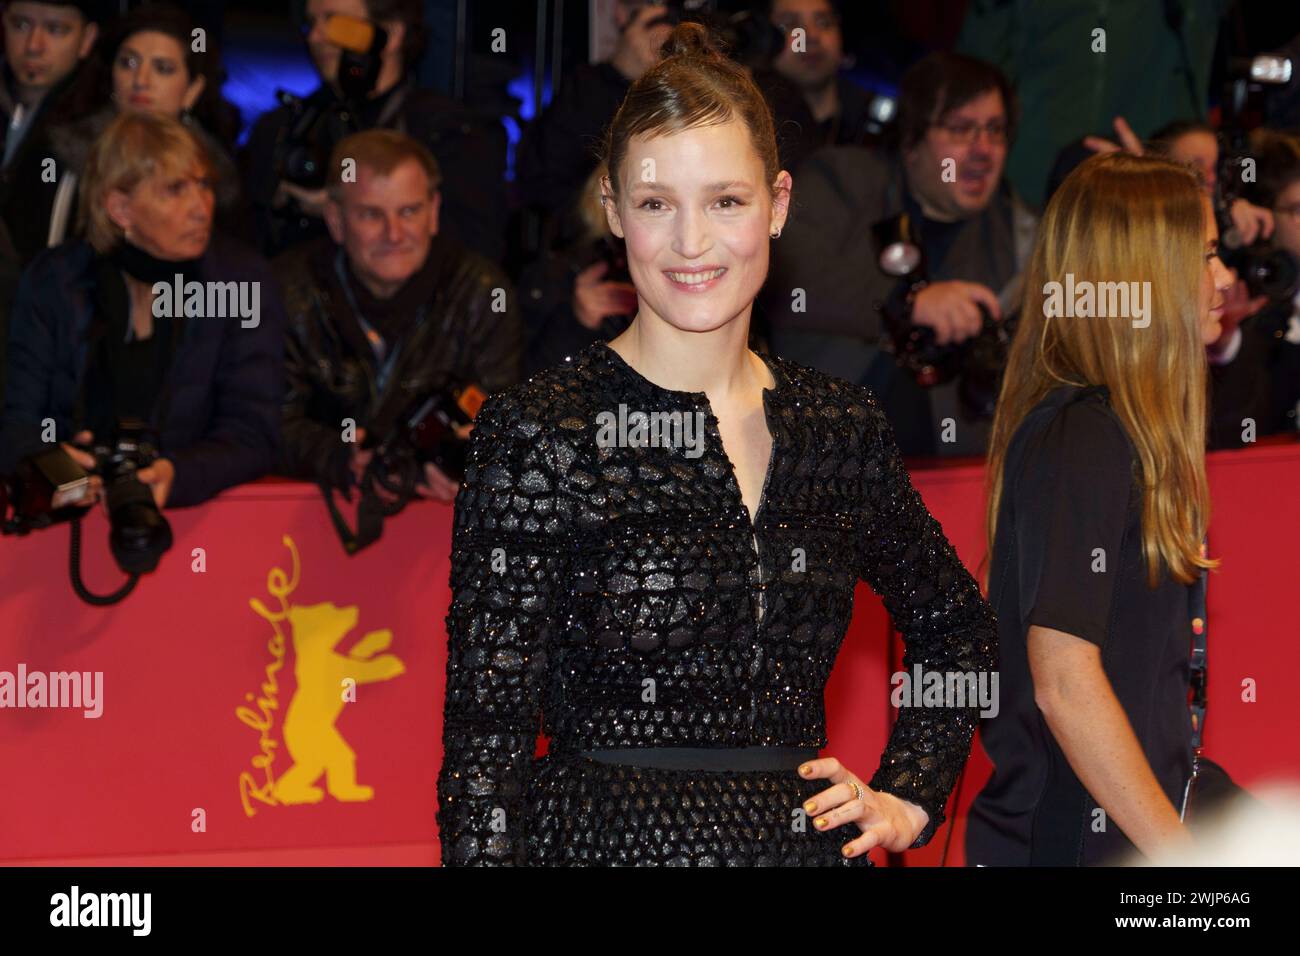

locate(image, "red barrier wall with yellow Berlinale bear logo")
[[0, 445, 1300, 865]]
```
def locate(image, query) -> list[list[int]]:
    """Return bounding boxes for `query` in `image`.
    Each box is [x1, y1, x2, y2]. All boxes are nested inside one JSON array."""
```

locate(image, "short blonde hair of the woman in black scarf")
[[77, 113, 217, 252]]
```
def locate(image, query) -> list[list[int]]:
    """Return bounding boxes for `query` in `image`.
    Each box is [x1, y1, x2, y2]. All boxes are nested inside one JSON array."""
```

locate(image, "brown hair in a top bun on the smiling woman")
[[602, 21, 781, 202]]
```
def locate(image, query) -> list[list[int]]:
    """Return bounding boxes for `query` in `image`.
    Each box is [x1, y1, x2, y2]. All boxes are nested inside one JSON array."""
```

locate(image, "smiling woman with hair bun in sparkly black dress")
[[438, 23, 996, 866]]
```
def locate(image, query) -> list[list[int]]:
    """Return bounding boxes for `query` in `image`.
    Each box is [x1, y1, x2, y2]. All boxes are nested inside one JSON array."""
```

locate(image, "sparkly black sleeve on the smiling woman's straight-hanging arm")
[[437, 395, 571, 866]]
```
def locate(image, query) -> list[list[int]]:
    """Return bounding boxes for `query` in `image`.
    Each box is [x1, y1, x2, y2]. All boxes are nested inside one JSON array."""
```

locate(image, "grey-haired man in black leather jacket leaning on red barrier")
[[276, 130, 523, 512]]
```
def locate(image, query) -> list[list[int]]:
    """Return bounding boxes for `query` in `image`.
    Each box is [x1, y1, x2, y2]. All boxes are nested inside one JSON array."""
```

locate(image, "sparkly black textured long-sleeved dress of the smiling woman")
[[437, 342, 997, 865]]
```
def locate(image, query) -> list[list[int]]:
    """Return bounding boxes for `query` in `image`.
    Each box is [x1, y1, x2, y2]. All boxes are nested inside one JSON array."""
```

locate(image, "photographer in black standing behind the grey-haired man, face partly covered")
[[241, 0, 506, 260]]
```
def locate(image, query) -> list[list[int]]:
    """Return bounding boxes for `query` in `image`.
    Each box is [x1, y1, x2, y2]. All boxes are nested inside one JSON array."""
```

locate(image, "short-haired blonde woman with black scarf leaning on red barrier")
[[0, 113, 283, 507]]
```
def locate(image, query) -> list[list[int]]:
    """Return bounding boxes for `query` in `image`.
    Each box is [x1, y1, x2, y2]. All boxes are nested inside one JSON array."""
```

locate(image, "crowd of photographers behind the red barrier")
[[0, 0, 1300, 571]]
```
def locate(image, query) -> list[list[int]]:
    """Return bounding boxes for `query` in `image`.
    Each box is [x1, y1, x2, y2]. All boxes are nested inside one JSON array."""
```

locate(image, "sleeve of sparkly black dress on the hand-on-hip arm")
[[861, 398, 997, 848]]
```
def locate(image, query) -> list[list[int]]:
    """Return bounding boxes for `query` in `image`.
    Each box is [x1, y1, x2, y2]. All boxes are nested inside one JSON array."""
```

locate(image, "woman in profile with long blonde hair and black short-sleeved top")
[[966, 152, 1232, 866]]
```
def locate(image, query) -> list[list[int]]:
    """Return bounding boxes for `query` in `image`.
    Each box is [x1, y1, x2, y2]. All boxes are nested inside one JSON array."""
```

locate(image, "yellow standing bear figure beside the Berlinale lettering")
[[273, 602, 406, 804]]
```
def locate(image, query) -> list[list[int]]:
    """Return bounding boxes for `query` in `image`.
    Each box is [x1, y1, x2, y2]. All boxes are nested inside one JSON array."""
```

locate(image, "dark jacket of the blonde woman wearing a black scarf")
[[0, 234, 285, 507]]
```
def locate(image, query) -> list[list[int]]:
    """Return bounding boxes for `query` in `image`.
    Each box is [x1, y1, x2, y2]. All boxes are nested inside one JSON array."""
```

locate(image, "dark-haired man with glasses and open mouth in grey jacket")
[[764, 53, 1035, 455]]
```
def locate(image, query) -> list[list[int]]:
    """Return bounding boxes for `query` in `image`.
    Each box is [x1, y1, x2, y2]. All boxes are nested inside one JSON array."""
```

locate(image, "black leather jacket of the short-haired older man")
[[274, 234, 523, 488]]
